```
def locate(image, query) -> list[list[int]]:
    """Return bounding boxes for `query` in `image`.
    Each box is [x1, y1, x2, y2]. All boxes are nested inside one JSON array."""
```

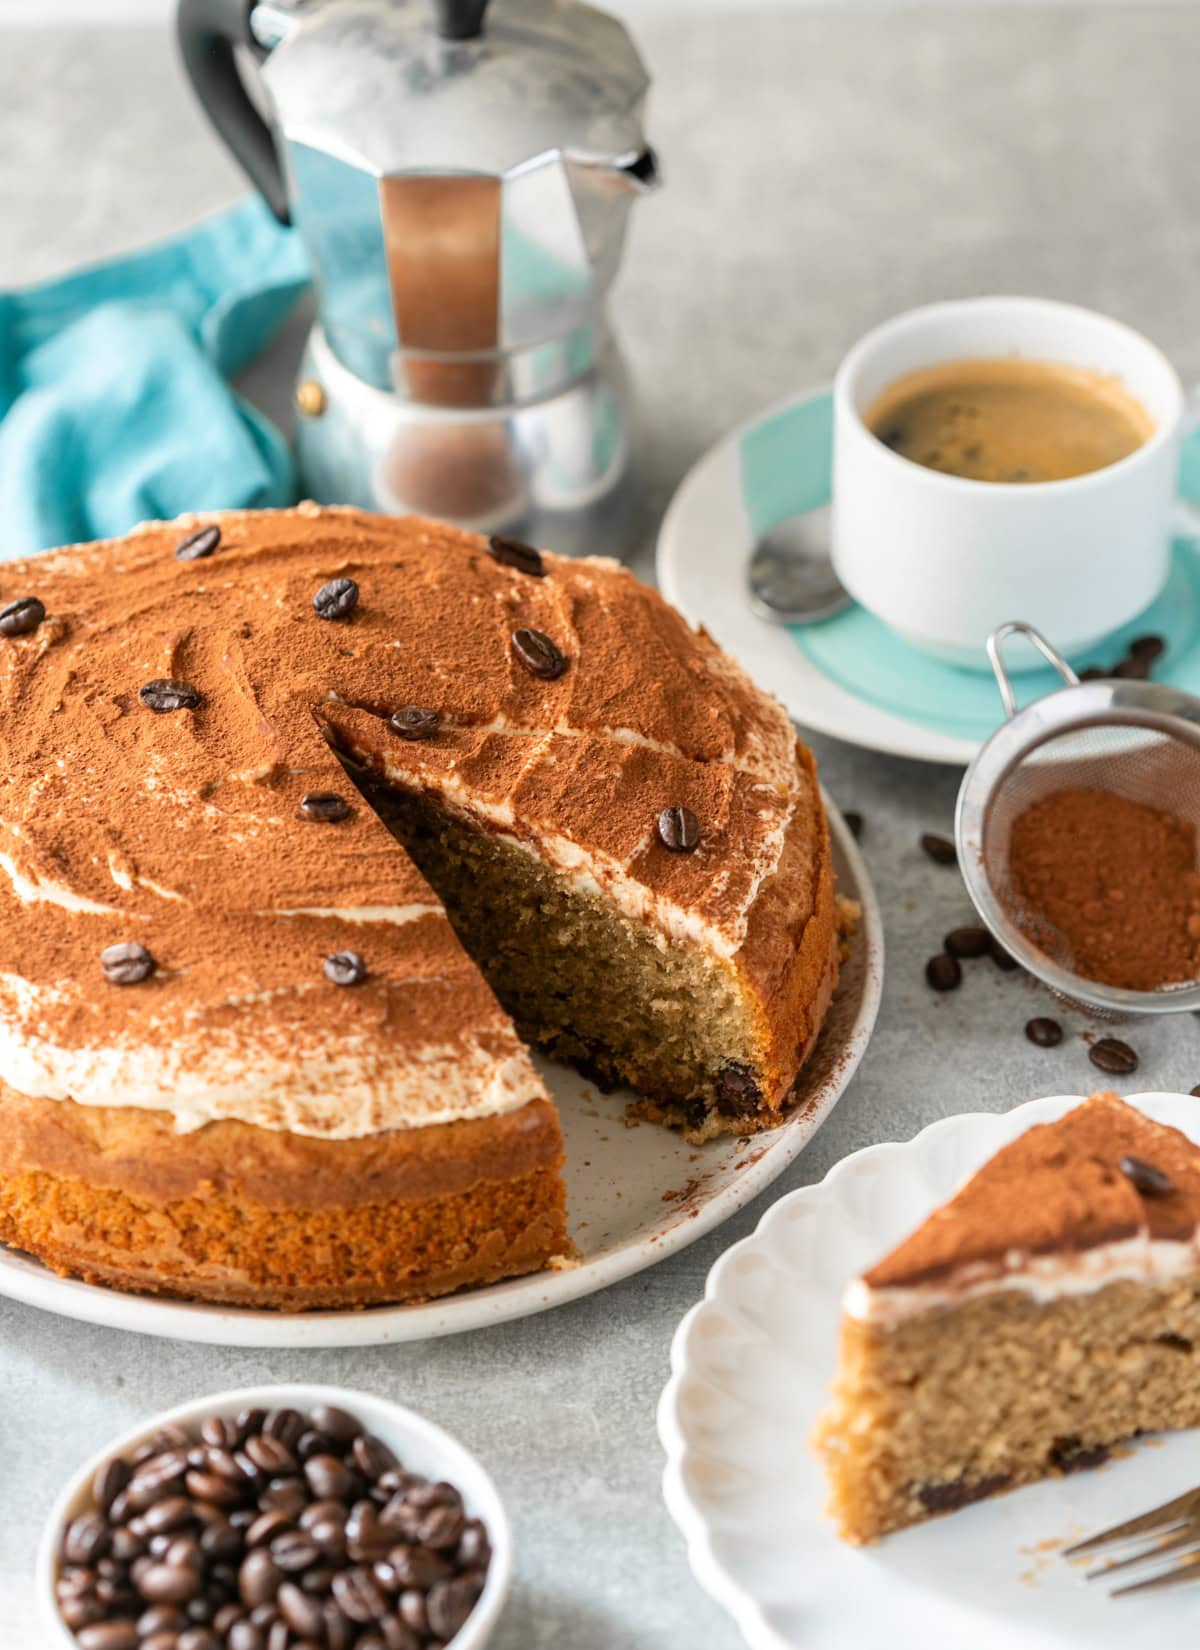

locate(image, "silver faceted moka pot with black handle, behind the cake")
[[178, 0, 659, 553]]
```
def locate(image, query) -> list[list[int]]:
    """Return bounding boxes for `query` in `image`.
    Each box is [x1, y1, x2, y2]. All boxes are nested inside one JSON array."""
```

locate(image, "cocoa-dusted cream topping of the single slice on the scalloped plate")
[[847, 1092, 1200, 1320]]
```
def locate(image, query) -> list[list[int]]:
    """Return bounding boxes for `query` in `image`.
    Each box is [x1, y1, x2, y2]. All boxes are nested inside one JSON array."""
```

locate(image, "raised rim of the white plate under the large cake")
[[0, 787, 883, 1348]]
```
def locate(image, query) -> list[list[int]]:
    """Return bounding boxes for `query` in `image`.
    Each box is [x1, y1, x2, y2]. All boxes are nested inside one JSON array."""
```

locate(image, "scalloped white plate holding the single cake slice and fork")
[[659, 1094, 1200, 1650]]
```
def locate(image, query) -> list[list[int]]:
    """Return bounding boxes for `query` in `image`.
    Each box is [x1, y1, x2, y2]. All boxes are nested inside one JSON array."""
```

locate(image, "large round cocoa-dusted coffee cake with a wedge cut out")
[[0, 505, 839, 1310]]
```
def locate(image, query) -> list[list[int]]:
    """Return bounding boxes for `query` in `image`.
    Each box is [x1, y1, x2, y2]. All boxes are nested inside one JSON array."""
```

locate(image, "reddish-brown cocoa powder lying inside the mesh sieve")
[[1009, 789, 1200, 992]]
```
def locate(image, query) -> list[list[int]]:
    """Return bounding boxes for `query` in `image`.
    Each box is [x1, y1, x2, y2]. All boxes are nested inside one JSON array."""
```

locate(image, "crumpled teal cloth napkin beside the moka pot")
[[0, 196, 309, 559]]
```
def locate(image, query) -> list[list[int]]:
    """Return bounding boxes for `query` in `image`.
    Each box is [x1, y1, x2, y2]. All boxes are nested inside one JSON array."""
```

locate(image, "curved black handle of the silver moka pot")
[[175, 0, 291, 223]]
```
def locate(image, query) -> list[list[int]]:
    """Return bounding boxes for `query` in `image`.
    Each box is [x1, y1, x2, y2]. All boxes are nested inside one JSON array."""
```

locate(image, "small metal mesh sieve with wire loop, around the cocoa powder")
[[954, 624, 1200, 1018]]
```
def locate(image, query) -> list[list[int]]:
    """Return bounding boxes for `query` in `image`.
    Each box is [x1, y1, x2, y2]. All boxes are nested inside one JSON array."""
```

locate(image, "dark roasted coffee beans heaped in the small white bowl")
[[54, 1404, 492, 1650]]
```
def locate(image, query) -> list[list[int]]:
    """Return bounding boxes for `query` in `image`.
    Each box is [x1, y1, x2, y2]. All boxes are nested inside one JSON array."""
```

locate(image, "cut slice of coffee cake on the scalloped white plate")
[[814, 1094, 1200, 1541]]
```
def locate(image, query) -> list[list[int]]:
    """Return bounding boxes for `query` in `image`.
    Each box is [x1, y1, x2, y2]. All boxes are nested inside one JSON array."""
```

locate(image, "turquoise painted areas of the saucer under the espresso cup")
[[739, 391, 1200, 741]]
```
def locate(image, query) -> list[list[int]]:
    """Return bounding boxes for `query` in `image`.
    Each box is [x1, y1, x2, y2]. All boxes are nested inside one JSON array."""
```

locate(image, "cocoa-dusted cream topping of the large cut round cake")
[[0, 505, 820, 1135]]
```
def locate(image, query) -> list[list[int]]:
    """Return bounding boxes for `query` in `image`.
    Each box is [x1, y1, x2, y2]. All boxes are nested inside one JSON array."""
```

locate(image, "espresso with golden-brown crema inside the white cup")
[[863, 355, 1155, 482]]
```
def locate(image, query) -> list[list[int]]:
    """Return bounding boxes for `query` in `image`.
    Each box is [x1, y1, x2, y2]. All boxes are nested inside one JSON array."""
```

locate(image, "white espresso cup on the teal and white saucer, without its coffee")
[[832, 297, 1185, 668]]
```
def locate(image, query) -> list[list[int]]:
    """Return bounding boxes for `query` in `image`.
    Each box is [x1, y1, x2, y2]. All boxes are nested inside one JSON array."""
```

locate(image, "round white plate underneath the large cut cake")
[[0, 797, 883, 1346]]
